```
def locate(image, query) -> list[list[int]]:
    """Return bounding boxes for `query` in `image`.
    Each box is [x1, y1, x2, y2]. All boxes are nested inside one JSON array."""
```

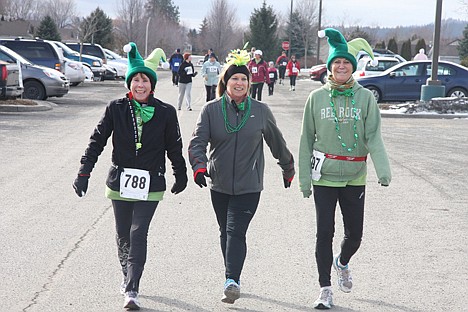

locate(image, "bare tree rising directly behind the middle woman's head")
[[205, 0, 242, 58]]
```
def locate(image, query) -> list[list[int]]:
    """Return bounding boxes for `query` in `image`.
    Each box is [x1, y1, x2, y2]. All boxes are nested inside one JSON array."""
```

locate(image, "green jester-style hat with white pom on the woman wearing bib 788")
[[123, 42, 160, 90]]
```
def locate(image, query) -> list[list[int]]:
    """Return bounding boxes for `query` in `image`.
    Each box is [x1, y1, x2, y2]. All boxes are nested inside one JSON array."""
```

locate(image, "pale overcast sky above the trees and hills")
[[76, 0, 468, 29]]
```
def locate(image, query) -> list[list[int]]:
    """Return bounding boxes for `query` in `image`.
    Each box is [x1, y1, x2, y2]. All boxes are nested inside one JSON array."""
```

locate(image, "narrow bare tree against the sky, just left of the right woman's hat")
[[296, 0, 318, 67]]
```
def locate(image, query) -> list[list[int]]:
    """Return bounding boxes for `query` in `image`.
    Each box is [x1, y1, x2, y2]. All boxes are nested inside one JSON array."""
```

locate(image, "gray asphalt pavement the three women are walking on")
[[0, 72, 468, 312]]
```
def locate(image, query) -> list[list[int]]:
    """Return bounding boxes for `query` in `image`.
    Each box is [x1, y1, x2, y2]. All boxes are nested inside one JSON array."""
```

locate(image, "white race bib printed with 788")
[[120, 168, 151, 200]]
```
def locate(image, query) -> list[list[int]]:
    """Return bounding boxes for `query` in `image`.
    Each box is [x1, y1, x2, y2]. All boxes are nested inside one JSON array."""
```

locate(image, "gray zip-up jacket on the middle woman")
[[188, 95, 295, 195]]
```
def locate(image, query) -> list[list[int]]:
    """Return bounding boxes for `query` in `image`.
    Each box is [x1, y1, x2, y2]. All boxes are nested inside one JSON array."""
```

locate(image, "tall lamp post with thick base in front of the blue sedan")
[[421, 0, 445, 101]]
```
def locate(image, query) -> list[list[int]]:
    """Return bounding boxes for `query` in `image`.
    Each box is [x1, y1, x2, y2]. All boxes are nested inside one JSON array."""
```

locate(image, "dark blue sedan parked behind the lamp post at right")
[[356, 60, 468, 102]]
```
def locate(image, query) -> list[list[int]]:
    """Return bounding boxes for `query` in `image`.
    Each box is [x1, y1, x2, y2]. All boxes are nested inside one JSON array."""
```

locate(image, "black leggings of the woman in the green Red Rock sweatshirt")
[[314, 186, 366, 287]]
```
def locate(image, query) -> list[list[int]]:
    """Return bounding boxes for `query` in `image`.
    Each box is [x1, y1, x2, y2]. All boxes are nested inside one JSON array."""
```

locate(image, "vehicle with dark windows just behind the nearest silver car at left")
[[0, 38, 65, 73]]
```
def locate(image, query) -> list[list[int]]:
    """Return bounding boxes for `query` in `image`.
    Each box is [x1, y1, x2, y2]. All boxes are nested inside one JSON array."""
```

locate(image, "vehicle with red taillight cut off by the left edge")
[[0, 60, 23, 99]]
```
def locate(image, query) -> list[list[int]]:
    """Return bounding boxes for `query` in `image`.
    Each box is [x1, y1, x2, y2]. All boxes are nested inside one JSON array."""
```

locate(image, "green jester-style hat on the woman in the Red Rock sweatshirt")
[[318, 28, 377, 72]]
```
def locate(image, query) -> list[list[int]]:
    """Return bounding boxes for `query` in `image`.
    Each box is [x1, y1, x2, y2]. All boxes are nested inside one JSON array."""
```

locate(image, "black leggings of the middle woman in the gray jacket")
[[211, 191, 260, 282]]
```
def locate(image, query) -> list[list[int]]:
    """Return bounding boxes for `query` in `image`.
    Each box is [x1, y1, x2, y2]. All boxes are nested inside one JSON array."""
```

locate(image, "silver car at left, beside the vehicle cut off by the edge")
[[0, 45, 70, 100]]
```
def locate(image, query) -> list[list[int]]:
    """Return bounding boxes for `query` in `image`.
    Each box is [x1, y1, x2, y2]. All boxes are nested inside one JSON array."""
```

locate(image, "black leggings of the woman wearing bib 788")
[[112, 200, 159, 292]]
